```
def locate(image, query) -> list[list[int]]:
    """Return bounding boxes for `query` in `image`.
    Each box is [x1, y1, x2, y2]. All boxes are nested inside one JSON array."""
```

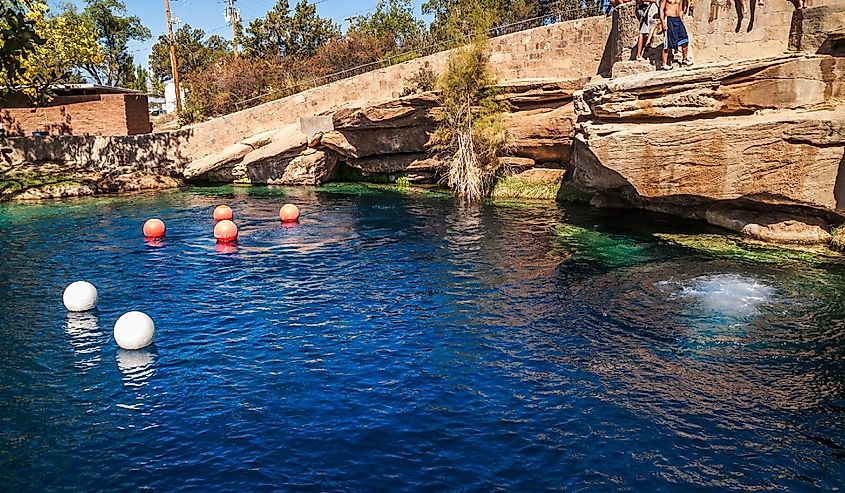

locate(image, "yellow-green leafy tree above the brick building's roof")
[[0, 1, 103, 101]]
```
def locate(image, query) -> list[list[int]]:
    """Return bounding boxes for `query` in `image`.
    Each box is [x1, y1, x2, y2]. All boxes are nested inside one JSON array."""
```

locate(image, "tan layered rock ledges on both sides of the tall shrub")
[[184, 79, 587, 185]]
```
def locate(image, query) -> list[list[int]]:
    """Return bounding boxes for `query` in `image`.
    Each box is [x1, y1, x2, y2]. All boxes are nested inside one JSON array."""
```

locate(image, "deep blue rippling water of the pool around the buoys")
[[0, 187, 845, 492]]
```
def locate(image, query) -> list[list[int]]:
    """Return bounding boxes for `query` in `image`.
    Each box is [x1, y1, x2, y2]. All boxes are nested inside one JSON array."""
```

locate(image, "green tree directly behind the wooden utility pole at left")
[[149, 24, 229, 83]]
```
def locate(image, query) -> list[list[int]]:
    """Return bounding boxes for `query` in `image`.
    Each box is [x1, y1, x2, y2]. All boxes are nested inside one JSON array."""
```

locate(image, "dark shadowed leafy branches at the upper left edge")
[[0, 0, 44, 93]]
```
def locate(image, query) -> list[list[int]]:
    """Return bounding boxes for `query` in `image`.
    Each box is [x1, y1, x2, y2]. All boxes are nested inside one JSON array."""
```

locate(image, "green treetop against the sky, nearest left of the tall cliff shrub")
[[350, 0, 424, 50]]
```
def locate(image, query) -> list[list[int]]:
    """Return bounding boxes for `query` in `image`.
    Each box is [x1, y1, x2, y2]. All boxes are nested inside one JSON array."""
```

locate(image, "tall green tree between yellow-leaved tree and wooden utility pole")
[[82, 0, 150, 86]]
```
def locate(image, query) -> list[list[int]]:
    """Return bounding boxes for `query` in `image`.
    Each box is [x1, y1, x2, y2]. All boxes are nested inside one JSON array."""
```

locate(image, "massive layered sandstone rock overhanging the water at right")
[[573, 51, 845, 243]]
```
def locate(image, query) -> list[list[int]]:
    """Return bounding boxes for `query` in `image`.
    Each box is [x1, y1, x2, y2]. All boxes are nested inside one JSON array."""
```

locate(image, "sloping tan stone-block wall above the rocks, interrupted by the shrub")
[[176, 16, 611, 163]]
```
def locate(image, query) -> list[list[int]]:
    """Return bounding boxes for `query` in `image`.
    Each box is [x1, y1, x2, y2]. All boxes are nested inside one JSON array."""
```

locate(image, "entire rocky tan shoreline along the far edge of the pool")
[[0, 2, 845, 250]]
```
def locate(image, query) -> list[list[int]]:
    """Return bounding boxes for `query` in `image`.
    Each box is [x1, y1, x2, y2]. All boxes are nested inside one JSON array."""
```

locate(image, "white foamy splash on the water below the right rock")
[[661, 274, 777, 316]]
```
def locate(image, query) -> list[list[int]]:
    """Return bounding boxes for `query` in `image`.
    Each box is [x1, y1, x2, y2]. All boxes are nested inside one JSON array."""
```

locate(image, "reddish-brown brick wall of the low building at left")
[[0, 94, 152, 136]]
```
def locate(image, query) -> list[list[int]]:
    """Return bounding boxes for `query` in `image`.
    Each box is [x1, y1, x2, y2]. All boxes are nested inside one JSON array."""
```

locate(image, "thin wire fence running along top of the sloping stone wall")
[[227, 5, 605, 111]]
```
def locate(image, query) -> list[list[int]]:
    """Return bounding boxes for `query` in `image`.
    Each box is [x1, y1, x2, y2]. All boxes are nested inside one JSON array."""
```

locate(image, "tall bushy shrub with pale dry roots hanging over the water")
[[432, 0, 507, 201]]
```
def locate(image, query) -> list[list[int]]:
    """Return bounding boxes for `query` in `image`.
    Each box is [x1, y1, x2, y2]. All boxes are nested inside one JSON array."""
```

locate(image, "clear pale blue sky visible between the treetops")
[[49, 0, 432, 71]]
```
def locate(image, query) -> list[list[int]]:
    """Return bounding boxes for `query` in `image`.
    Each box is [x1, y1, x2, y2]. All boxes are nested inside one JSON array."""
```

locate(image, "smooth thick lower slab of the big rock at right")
[[573, 106, 845, 210]]
